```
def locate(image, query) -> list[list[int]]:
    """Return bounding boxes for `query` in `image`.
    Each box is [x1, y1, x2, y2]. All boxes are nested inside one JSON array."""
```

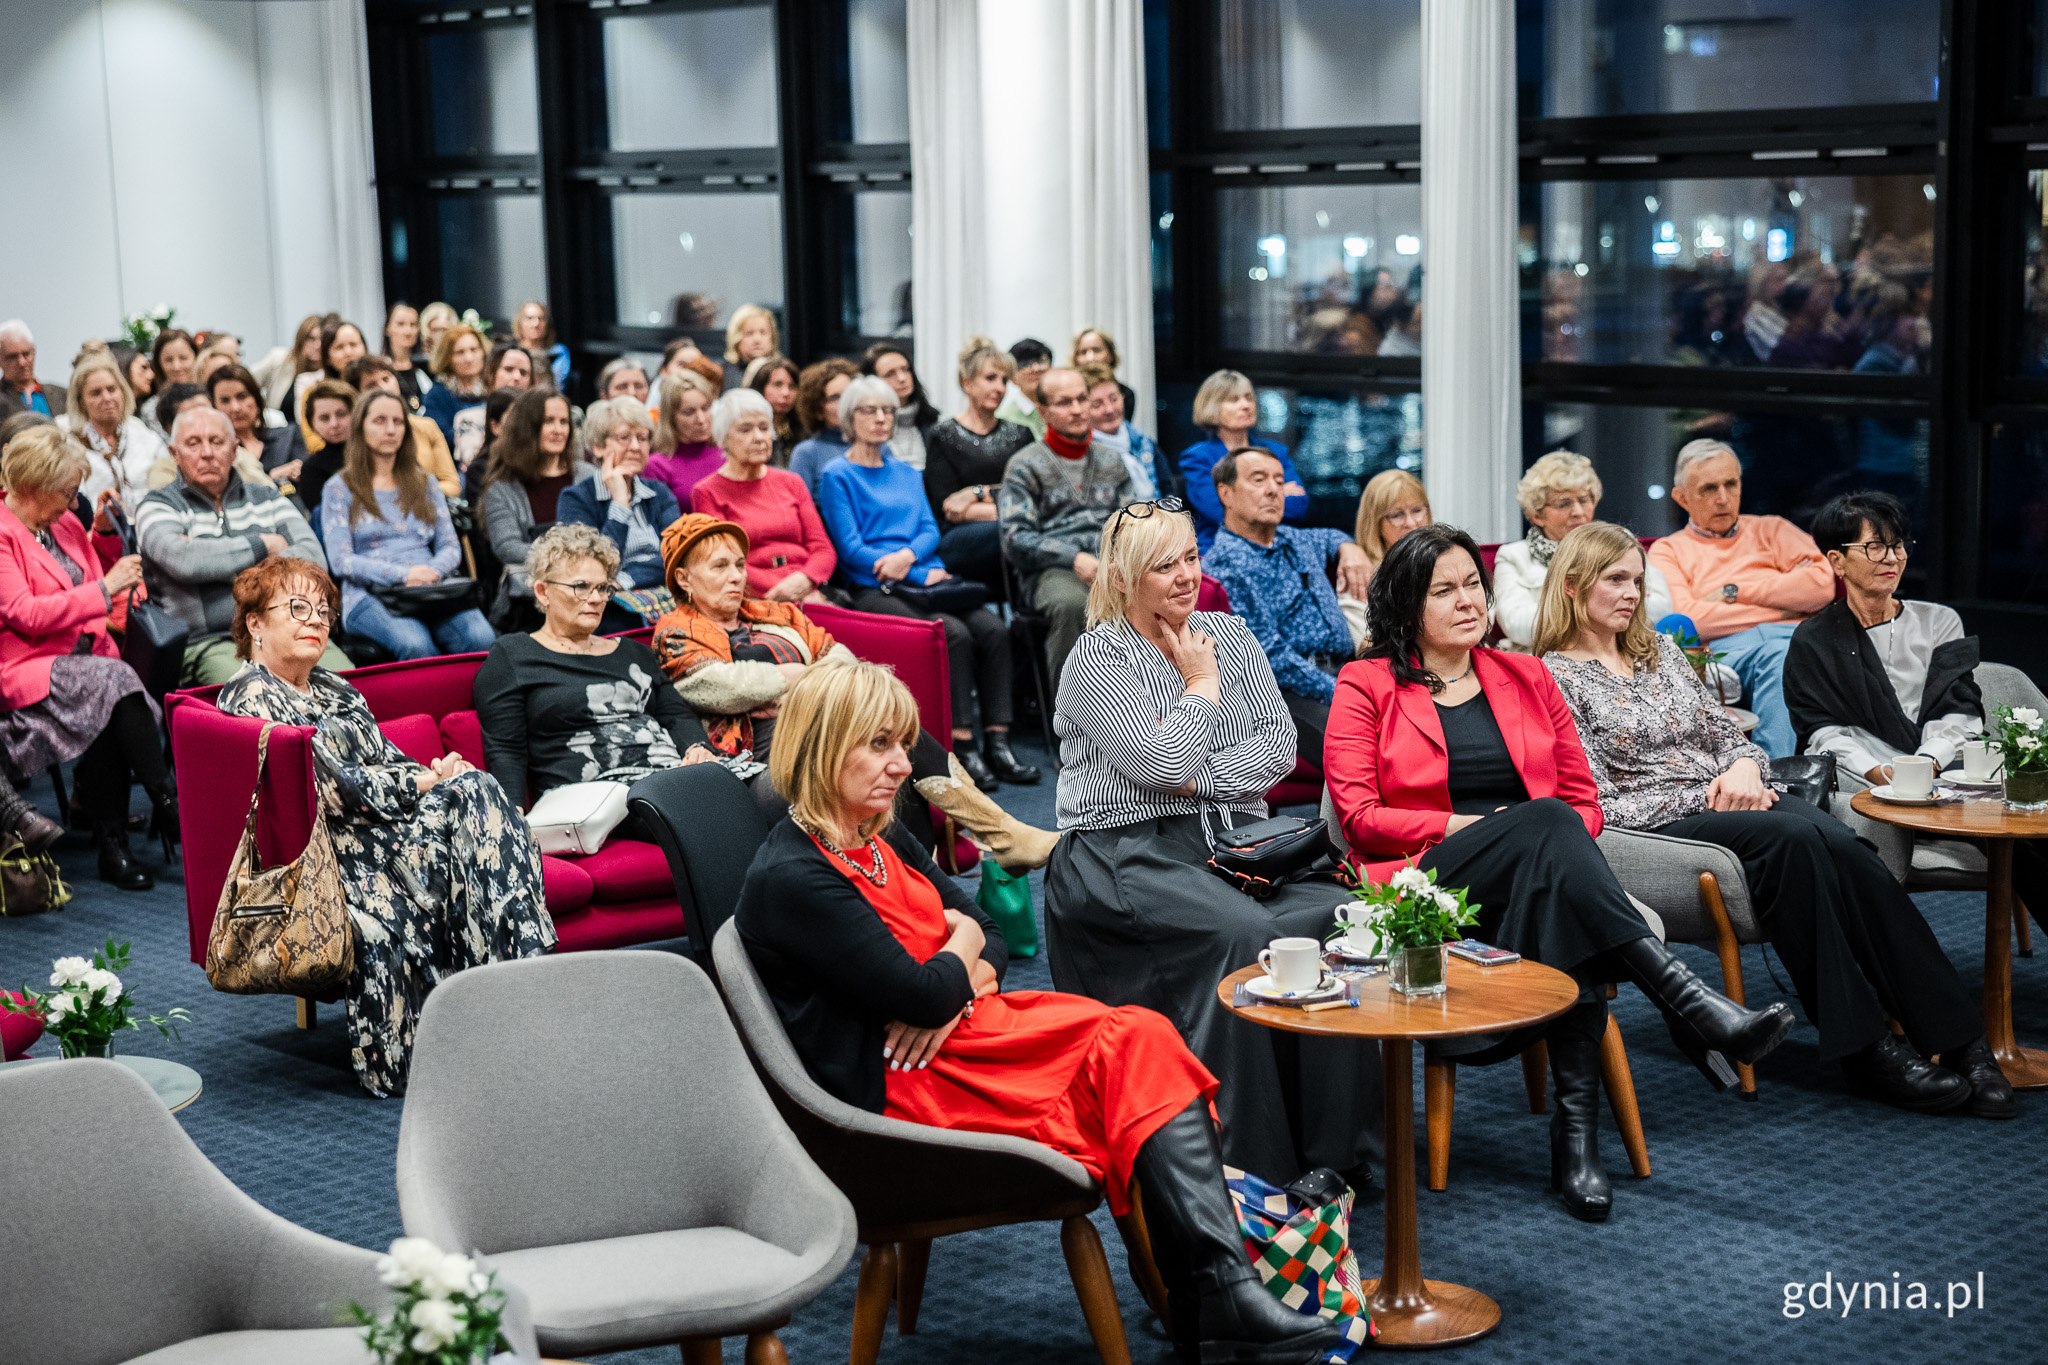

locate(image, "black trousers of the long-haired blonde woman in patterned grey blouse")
[[1657, 796, 1985, 1060]]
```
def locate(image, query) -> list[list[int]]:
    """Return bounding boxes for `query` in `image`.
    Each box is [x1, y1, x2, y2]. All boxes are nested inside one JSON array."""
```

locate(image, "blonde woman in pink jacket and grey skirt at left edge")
[[0, 426, 178, 890]]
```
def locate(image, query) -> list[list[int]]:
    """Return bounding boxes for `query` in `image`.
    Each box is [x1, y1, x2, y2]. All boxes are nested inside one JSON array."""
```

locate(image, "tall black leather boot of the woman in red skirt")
[[1133, 1099, 1337, 1365]]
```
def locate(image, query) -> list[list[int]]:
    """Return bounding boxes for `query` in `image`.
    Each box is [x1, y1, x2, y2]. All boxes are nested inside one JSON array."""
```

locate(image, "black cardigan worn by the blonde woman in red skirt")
[[733, 821, 1010, 1113]]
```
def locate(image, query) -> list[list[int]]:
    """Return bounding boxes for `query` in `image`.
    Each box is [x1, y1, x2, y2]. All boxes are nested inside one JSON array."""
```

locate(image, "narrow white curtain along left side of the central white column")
[[907, 0, 987, 415]]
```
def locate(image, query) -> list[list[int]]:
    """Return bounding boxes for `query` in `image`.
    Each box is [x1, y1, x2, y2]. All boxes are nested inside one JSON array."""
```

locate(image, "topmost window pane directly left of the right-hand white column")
[[1217, 0, 1421, 129]]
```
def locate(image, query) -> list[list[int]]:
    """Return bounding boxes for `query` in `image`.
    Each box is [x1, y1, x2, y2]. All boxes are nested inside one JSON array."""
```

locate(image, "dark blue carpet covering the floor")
[[0, 740, 2048, 1365]]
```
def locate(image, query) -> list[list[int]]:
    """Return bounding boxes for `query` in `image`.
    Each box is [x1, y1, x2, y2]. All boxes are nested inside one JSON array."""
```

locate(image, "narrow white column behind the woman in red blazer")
[[1421, 0, 1522, 542]]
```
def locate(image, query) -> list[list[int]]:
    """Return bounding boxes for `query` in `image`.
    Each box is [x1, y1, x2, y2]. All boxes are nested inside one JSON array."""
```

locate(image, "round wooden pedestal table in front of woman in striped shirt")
[[1217, 958, 1579, 1349]]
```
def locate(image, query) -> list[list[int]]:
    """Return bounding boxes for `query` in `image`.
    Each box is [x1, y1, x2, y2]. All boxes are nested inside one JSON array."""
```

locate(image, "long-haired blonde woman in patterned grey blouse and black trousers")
[[1532, 522, 2015, 1117]]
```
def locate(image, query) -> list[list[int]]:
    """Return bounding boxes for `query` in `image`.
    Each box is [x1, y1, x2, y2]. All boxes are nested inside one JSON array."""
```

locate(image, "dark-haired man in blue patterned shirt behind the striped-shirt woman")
[[1202, 446, 1372, 767]]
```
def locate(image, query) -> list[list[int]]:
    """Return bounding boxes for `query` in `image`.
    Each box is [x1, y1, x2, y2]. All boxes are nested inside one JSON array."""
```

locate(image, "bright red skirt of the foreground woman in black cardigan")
[[883, 990, 1217, 1218]]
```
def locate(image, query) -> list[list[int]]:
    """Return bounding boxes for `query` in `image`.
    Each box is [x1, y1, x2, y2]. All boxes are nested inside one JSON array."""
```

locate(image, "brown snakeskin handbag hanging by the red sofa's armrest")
[[207, 720, 356, 995]]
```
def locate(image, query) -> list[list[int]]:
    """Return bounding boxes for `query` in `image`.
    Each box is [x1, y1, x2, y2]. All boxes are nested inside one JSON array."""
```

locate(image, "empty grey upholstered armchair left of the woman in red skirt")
[[397, 952, 854, 1365]]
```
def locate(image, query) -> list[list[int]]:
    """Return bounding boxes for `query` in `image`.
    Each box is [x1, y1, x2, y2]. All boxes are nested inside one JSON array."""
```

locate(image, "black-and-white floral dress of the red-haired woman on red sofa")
[[219, 663, 555, 1097]]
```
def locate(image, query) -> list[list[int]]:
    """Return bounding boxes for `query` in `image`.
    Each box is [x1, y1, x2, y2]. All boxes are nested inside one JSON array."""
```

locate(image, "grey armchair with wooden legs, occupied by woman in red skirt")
[[711, 923, 1165, 1365]]
